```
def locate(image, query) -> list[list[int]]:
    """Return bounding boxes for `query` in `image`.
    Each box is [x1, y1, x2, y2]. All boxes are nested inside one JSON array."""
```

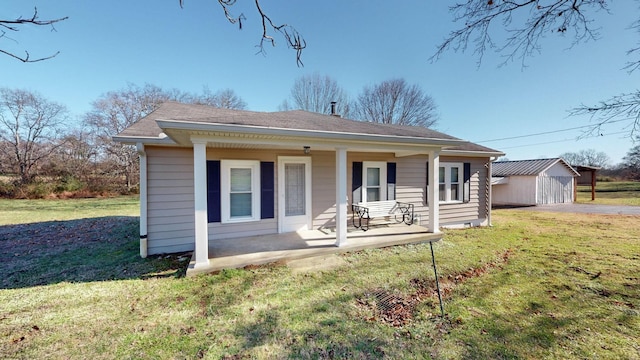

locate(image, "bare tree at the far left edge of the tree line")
[[0, 88, 67, 184]]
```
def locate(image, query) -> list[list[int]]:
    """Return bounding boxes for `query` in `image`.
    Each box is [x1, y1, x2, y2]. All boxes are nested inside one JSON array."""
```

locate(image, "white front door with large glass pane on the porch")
[[278, 156, 311, 233]]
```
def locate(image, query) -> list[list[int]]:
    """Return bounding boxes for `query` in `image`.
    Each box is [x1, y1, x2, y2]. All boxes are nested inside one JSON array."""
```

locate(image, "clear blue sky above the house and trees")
[[0, 0, 640, 163]]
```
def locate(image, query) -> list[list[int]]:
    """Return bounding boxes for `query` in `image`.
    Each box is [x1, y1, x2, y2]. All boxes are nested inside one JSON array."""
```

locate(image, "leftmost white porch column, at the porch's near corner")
[[191, 139, 209, 269]]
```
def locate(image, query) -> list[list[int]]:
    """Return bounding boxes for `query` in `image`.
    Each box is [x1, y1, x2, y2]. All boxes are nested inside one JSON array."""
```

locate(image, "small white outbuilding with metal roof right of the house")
[[491, 158, 580, 206]]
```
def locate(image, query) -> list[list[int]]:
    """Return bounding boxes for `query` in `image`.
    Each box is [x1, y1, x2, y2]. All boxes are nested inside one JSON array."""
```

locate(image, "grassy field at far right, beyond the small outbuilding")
[[576, 181, 640, 206]]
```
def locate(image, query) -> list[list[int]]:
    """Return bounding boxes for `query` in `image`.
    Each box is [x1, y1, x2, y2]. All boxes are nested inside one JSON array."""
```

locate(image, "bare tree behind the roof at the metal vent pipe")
[[280, 73, 351, 117]]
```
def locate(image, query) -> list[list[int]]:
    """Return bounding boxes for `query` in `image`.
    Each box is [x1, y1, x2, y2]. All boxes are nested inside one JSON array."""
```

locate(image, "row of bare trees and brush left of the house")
[[0, 84, 246, 198]]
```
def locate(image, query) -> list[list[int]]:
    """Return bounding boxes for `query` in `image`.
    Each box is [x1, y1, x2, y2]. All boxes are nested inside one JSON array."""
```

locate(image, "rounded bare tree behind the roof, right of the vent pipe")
[[355, 79, 438, 127]]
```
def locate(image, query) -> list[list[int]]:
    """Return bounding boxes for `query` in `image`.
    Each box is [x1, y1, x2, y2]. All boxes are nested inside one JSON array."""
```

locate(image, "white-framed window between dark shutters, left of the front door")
[[220, 160, 260, 223]]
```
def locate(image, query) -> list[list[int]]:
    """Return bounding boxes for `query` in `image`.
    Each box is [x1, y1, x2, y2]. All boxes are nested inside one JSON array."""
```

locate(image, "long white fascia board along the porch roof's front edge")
[[156, 120, 468, 146]]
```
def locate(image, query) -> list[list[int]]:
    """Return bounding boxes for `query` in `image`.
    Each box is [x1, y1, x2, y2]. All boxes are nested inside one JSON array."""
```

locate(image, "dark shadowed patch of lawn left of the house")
[[0, 216, 190, 289]]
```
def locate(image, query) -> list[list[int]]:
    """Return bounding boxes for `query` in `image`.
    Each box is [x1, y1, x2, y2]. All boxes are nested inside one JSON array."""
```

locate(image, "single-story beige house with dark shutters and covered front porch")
[[114, 102, 503, 269]]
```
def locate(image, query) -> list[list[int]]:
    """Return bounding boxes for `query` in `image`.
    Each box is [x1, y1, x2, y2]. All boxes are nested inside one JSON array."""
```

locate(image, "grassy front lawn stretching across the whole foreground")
[[0, 200, 640, 359]]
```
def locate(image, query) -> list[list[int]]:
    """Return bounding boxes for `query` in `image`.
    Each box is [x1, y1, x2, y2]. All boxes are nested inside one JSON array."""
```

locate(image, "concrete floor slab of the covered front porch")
[[187, 224, 442, 276]]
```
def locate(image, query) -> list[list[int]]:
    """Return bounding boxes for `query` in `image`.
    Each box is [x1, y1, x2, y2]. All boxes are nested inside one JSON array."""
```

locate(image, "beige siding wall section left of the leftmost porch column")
[[146, 146, 195, 254]]
